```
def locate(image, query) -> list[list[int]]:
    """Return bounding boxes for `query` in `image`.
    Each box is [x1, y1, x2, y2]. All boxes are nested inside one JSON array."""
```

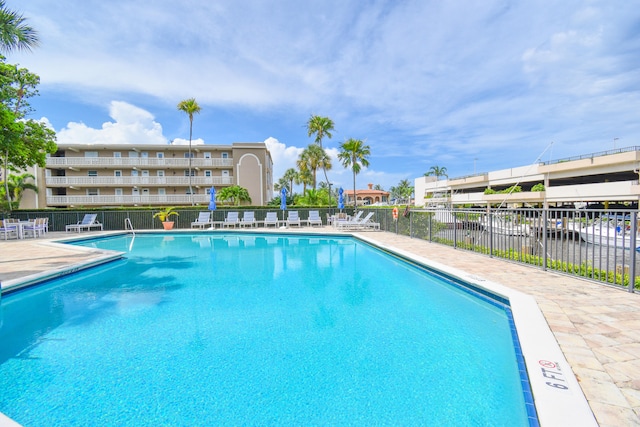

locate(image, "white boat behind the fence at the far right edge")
[[580, 215, 640, 250]]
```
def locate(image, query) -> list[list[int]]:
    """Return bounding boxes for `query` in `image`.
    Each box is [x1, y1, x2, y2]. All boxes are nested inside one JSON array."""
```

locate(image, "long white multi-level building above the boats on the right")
[[414, 147, 640, 207]]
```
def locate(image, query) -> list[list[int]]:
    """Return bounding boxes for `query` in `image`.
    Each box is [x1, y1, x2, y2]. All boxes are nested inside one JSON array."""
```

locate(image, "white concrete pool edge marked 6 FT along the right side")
[[353, 233, 598, 426]]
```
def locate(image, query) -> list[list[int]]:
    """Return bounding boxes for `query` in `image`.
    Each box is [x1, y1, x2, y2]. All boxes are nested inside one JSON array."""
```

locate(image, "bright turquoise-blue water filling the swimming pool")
[[0, 233, 535, 427]]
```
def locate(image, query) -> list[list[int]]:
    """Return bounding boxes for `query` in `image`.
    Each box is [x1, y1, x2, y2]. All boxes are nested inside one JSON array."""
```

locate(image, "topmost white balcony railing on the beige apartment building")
[[47, 157, 233, 168]]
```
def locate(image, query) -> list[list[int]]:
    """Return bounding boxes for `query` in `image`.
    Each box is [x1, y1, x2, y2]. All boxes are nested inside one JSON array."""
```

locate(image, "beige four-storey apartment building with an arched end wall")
[[21, 142, 273, 208]]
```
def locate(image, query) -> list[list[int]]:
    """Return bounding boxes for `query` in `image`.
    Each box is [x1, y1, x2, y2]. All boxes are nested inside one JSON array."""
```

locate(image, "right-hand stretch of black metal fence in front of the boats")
[[360, 208, 640, 292]]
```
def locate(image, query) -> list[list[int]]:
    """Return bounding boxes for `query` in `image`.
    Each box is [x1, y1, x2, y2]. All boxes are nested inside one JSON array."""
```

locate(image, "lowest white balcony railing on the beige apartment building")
[[47, 194, 209, 206]]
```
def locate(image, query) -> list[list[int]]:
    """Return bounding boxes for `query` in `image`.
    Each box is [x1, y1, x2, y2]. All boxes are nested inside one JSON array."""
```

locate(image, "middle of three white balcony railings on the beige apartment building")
[[45, 176, 233, 187]]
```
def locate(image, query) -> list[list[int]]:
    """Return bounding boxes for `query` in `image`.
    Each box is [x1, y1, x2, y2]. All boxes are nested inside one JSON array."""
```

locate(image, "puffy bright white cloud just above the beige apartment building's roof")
[[58, 101, 168, 145]]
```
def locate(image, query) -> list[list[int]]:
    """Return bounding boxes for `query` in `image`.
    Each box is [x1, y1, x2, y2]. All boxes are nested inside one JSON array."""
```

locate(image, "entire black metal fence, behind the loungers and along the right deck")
[[3, 207, 640, 292]]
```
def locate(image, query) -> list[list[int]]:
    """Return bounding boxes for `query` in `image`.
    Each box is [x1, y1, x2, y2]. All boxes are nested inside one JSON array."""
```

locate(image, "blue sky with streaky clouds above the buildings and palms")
[[7, 0, 640, 189]]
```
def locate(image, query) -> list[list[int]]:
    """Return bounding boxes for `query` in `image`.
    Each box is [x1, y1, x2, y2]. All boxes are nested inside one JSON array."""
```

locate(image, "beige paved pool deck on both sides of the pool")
[[0, 228, 640, 427]]
